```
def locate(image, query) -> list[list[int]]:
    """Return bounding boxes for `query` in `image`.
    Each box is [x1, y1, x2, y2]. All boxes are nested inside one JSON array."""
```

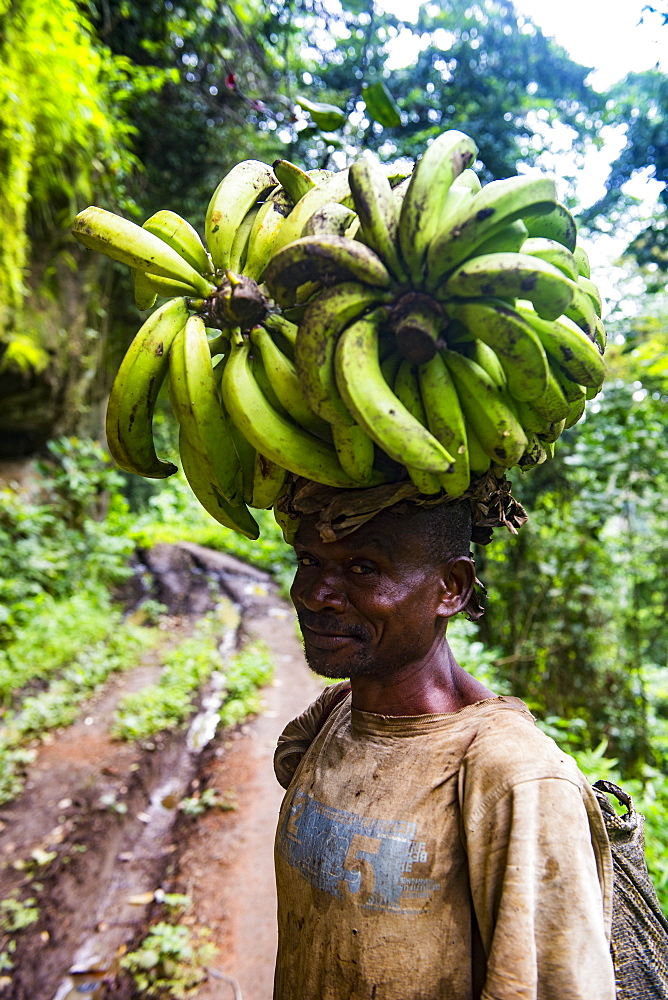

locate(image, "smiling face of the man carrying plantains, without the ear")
[[290, 513, 452, 677]]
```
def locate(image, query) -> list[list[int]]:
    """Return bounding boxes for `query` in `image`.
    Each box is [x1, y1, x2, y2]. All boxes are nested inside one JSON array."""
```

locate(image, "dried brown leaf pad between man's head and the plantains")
[[276, 472, 527, 621]]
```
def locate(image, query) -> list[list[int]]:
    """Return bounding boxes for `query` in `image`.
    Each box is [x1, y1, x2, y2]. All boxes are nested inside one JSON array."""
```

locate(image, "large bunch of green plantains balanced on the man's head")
[[73, 130, 605, 538]]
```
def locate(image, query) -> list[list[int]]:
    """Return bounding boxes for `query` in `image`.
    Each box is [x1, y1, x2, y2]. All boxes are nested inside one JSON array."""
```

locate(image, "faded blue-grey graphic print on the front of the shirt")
[[277, 788, 441, 914]]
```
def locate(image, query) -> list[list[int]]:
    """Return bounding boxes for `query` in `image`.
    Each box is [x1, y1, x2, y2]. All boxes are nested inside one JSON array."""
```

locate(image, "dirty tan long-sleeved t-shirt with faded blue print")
[[274, 687, 615, 1000]]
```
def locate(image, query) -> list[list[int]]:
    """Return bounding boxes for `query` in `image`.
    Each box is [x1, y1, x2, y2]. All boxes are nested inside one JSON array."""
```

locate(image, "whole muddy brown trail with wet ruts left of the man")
[[0, 543, 321, 1000]]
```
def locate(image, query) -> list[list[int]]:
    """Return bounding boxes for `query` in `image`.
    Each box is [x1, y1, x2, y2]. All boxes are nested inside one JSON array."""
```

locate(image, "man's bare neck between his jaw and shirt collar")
[[350, 638, 495, 715]]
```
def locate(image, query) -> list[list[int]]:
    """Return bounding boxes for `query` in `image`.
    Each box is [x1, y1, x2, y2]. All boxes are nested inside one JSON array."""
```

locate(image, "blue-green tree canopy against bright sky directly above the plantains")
[[277, 0, 604, 179]]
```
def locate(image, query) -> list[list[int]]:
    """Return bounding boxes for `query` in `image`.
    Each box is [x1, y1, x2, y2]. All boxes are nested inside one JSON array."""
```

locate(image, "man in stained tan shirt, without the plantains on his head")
[[274, 490, 615, 1000]]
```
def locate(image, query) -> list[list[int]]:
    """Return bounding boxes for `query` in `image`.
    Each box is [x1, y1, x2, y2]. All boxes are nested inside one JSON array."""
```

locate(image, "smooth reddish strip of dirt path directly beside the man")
[[178, 597, 322, 1000]]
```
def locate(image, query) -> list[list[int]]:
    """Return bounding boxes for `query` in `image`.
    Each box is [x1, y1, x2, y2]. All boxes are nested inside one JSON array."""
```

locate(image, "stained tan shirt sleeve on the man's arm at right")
[[462, 777, 615, 1000]]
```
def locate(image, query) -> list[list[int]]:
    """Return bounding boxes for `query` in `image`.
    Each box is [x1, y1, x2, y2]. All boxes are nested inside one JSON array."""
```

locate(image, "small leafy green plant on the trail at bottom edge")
[[121, 921, 216, 1000]]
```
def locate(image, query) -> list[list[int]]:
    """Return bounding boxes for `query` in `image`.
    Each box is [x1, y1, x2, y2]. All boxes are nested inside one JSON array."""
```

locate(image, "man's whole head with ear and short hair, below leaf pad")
[[291, 501, 474, 677]]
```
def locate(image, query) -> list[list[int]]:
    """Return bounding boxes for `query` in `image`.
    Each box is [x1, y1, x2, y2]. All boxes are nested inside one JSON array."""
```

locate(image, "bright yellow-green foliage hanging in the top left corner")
[[0, 0, 150, 340]]
